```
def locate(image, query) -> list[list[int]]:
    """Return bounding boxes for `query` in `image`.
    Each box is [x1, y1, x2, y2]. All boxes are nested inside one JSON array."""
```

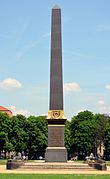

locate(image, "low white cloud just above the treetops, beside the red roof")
[[9, 106, 31, 116]]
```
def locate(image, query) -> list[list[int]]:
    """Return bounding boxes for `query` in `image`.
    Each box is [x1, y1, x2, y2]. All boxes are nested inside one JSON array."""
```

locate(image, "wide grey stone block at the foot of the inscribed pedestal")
[[45, 147, 67, 162]]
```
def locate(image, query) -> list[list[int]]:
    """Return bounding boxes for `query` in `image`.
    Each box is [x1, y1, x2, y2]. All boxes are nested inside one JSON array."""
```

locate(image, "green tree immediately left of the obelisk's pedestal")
[[26, 116, 47, 159]]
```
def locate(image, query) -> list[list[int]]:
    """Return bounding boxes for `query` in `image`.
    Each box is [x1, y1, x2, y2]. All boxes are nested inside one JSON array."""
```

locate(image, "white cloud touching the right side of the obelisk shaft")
[[64, 82, 81, 92]]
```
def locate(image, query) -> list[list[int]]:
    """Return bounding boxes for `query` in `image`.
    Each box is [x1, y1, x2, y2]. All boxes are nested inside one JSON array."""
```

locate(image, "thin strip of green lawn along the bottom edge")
[[0, 174, 110, 179]]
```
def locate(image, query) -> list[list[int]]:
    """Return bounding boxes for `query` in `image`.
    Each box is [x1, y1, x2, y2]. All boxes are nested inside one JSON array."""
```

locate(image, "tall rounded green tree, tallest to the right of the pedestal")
[[71, 111, 95, 158]]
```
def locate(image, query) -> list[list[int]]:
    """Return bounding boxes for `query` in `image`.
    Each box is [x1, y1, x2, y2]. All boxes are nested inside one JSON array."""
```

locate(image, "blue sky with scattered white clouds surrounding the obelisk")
[[0, 0, 110, 119]]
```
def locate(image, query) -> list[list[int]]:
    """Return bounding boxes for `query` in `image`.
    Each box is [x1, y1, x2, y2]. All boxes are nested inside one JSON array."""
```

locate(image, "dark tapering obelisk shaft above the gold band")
[[50, 7, 63, 110]]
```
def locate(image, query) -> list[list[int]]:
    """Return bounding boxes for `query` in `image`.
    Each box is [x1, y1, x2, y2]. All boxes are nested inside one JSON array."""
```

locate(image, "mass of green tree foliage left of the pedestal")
[[0, 113, 47, 159]]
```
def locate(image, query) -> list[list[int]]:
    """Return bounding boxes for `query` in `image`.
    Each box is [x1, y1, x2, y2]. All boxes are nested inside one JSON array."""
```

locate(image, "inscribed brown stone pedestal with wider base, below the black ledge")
[[45, 125, 67, 162]]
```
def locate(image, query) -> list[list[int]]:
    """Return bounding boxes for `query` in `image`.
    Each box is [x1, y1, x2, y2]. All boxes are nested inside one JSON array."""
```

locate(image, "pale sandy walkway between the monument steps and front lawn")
[[0, 165, 110, 174]]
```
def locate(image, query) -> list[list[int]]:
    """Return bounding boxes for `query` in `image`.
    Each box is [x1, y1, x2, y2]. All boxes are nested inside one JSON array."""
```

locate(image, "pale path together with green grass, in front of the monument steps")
[[0, 161, 110, 179]]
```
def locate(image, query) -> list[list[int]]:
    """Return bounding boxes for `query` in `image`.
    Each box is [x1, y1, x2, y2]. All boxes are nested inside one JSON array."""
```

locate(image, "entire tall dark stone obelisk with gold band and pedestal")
[[45, 5, 67, 162]]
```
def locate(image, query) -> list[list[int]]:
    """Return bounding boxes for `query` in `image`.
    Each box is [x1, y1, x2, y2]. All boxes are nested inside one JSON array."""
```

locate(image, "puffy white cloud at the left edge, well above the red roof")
[[0, 78, 22, 89]]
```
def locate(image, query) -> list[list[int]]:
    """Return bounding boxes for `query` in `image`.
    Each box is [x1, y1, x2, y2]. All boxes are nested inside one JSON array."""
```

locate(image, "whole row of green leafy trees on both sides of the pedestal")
[[0, 111, 110, 159]]
